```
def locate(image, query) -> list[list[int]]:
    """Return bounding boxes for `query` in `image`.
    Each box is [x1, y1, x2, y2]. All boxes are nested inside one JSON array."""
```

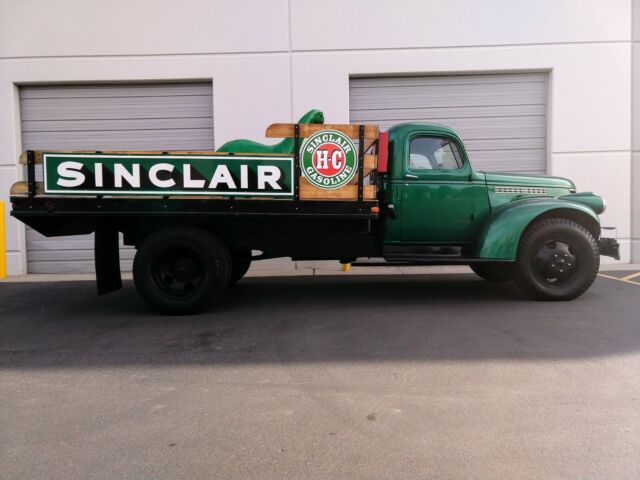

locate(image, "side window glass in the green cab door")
[[409, 137, 462, 170]]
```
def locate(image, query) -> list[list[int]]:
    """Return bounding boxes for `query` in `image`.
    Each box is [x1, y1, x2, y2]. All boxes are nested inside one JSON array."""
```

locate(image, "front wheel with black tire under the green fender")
[[514, 218, 600, 300]]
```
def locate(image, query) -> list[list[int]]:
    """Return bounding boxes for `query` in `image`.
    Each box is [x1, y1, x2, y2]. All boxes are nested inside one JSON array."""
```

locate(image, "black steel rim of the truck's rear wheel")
[[152, 246, 207, 298]]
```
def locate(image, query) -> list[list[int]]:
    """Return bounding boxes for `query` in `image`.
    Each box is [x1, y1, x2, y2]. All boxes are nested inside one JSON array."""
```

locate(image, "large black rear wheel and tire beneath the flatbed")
[[133, 227, 231, 315]]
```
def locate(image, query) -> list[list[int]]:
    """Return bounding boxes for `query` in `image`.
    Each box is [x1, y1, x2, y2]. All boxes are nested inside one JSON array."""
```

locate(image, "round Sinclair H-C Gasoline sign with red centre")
[[300, 130, 358, 190]]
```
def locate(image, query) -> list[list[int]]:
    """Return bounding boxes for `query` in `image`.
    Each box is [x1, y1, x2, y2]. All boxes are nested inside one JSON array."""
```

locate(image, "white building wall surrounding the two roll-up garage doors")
[[0, 0, 640, 274]]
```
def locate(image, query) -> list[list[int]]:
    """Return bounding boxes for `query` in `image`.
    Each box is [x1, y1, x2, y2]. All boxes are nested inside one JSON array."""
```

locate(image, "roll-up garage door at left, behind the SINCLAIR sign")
[[20, 82, 214, 273]]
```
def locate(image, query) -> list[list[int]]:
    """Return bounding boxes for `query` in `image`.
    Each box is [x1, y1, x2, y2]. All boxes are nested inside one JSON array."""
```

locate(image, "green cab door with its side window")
[[398, 135, 489, 245]]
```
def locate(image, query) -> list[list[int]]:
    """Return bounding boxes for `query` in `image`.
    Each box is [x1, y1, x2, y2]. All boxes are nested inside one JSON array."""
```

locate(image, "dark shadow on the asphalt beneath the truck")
[[0, 275, 640, 368]]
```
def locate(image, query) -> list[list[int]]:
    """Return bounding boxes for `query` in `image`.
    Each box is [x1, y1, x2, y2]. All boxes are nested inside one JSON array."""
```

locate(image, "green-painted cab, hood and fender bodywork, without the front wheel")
[[381, 123, 605, 260]]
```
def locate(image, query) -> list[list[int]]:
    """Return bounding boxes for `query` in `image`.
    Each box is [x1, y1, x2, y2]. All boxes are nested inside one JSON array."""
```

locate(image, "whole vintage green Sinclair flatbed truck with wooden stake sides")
[[11, 111, 619, 314]]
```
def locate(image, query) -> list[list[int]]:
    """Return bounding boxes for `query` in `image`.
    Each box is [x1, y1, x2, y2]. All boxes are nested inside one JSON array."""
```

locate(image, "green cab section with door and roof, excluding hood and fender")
[[384, 124, 491, 248]]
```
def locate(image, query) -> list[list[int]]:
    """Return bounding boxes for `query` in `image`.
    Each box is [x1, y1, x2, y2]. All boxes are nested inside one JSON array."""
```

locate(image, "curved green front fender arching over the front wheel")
[[476, 198, 600, 260]]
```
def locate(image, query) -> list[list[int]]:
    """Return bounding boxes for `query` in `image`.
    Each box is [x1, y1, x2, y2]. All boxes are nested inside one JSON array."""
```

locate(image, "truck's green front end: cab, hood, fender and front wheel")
[[381, 123, 619, 299]]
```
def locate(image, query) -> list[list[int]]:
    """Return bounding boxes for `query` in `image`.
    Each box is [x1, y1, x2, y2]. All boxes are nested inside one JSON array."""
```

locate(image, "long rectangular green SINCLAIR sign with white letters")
[[42, 152, 294, 197]]
